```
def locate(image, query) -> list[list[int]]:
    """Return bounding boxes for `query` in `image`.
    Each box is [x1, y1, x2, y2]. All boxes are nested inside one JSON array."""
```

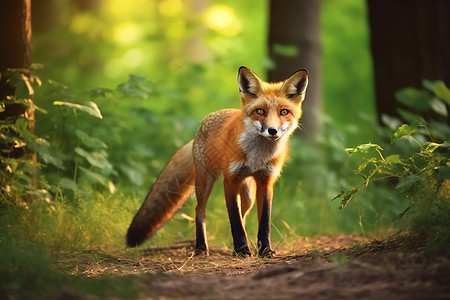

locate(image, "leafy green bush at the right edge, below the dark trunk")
[[335, 81, 450, 249]]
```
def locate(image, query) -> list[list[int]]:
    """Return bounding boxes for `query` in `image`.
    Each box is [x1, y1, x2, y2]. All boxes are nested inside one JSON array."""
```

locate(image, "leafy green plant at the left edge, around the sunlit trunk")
[[0, 69, 47, 205]]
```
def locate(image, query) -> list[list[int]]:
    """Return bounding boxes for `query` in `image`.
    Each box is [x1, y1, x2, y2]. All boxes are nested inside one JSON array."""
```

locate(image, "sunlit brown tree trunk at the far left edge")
[[0, 0, 34, 156]]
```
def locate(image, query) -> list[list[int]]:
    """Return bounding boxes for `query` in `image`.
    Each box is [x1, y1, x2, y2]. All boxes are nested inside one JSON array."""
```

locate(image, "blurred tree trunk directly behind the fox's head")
[[268, 0, 322, 139]]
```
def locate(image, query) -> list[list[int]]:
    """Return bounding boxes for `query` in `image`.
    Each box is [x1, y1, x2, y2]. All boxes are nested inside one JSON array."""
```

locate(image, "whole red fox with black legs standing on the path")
[[126, 66, 308, 257]]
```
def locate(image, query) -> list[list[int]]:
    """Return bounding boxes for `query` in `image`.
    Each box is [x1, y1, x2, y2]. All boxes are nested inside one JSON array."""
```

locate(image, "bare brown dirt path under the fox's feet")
[[44, 235, 450, 300]]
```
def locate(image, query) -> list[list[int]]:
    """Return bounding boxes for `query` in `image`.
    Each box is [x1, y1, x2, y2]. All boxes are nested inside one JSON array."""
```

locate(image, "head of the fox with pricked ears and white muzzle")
[[238, 66, 308, 141]]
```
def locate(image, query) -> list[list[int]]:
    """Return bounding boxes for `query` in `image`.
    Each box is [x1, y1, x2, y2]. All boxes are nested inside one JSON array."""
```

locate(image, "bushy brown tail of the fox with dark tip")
[[127, 140, 195, 247]]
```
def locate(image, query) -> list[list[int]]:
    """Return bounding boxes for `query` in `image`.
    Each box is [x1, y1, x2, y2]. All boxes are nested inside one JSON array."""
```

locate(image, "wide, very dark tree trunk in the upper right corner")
[[367, 0, 450, 123]]
